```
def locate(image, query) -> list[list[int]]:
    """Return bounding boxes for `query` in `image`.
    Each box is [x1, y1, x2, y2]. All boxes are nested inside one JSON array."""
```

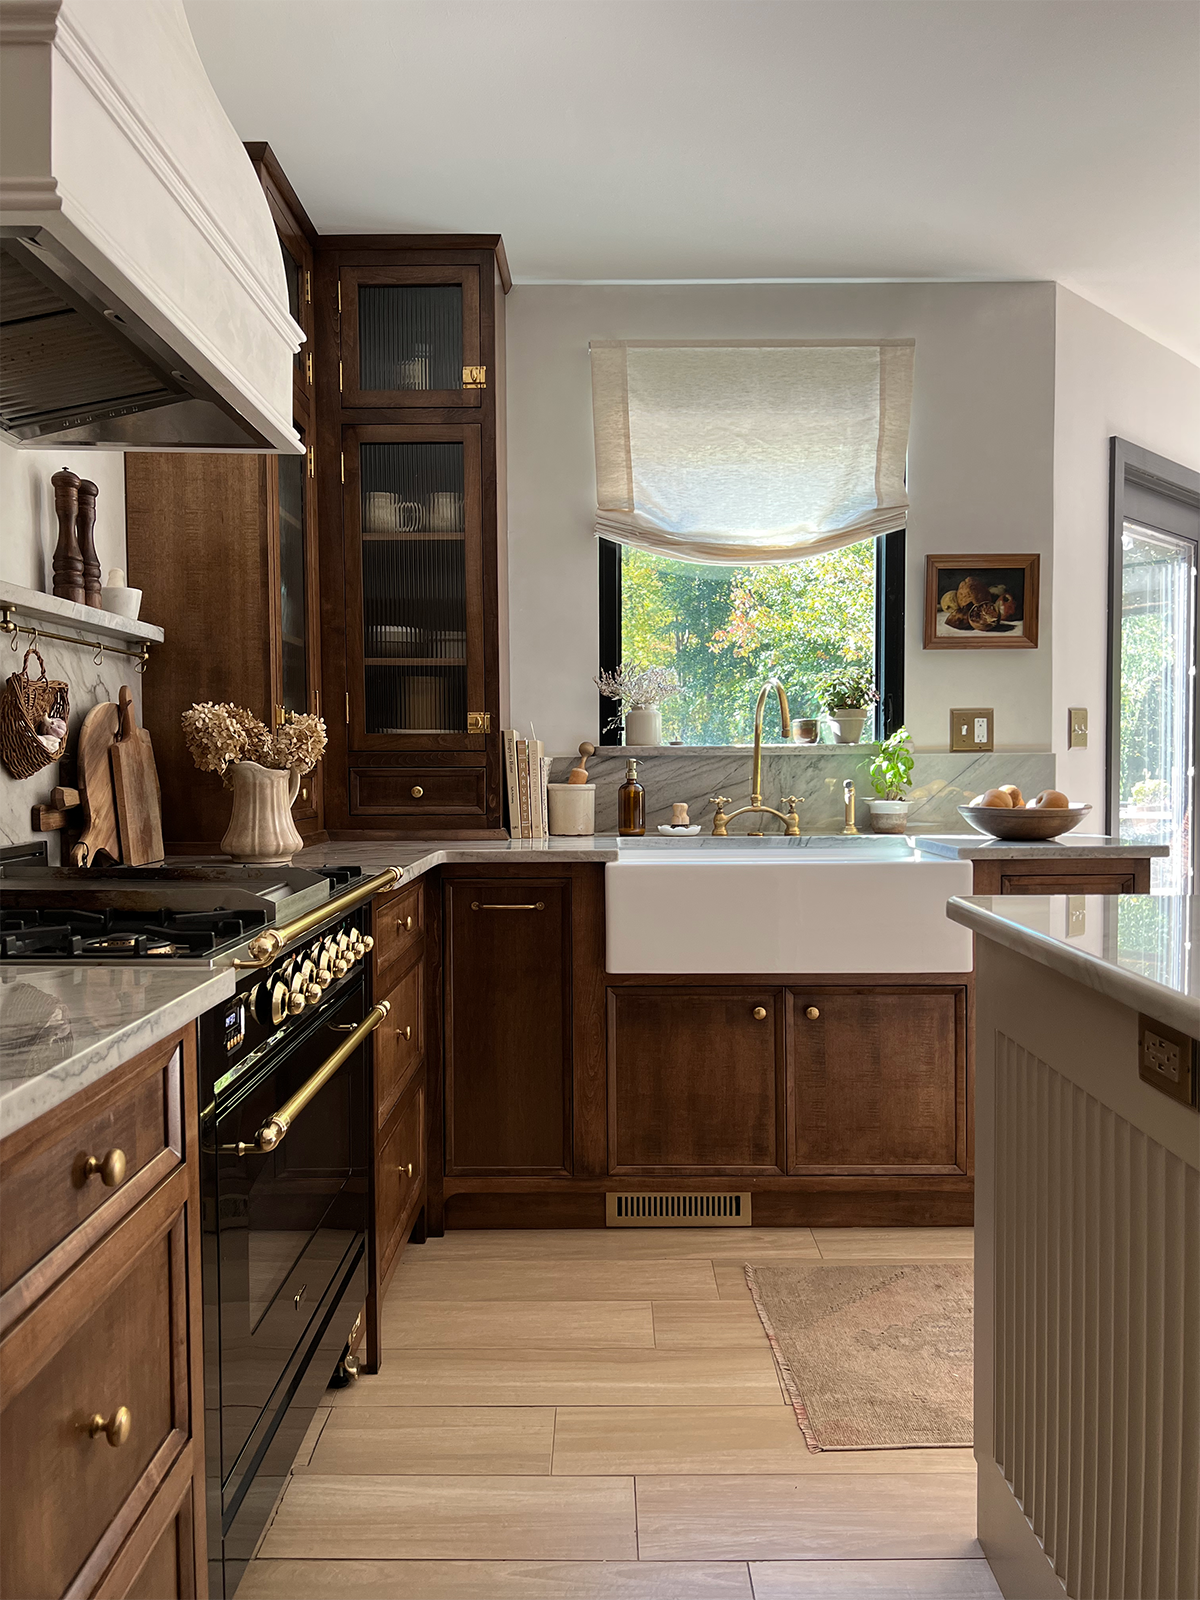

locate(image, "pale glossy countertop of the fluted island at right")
[[947, 894, 1200, 1037]]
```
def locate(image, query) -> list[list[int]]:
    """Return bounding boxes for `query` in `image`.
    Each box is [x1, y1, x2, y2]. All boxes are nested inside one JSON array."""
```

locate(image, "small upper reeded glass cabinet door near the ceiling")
[[339, 266, 486, 408]]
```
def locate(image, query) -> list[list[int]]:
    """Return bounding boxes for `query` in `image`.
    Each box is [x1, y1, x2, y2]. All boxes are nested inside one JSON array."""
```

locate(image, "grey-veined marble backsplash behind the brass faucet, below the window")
[[550, 744, 1054, 834]]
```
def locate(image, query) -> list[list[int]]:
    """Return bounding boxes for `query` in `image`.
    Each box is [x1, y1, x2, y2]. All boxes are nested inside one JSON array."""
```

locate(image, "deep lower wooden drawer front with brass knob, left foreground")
[[0, 1173, 190, 1600]]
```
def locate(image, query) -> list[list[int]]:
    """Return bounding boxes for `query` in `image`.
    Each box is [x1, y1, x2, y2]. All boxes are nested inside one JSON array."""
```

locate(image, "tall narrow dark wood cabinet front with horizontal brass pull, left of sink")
[[443, 877, 571, 1174]]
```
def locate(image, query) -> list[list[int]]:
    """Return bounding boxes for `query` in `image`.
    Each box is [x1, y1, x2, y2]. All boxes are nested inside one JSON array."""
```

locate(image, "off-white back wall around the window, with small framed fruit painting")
[[507, 283, 1054, 752]]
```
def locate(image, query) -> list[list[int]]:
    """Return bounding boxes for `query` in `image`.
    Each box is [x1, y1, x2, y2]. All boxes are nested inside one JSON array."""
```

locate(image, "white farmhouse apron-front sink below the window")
[[605, 837, 971, 974]]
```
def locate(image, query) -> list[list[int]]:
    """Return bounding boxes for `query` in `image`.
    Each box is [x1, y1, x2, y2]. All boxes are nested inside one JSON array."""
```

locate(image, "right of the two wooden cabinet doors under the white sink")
[[787, 986, 966, 1174]]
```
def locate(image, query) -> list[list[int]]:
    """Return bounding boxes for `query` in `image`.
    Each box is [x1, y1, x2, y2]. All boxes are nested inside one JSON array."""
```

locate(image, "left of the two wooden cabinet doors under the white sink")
[[608, 987, 784, 1174]]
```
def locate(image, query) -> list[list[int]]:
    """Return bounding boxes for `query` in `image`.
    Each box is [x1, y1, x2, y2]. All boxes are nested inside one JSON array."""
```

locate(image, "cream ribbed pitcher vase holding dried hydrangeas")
[[182, 701, 325, 864]]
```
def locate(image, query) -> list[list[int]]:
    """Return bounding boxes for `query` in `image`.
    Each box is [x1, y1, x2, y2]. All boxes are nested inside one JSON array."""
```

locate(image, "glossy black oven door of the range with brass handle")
[[214, 986, 366, 1477]]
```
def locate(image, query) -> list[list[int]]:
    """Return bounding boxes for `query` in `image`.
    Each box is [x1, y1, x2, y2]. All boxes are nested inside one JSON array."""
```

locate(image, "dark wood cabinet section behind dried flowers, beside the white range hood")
[[125, 146, 323, 854]]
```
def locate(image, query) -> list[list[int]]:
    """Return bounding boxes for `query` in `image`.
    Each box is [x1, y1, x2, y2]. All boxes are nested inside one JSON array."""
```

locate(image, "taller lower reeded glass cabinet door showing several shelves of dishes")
[[346, 426, 485, 750]]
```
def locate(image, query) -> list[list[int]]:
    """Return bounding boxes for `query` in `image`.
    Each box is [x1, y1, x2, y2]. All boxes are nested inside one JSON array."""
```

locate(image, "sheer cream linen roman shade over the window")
[[590, 339, 914, 566]]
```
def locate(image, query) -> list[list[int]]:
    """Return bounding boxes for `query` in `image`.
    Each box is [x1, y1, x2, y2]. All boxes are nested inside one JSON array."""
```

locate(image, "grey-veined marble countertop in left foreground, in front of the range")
[[0, 962, 237, 1139]]
